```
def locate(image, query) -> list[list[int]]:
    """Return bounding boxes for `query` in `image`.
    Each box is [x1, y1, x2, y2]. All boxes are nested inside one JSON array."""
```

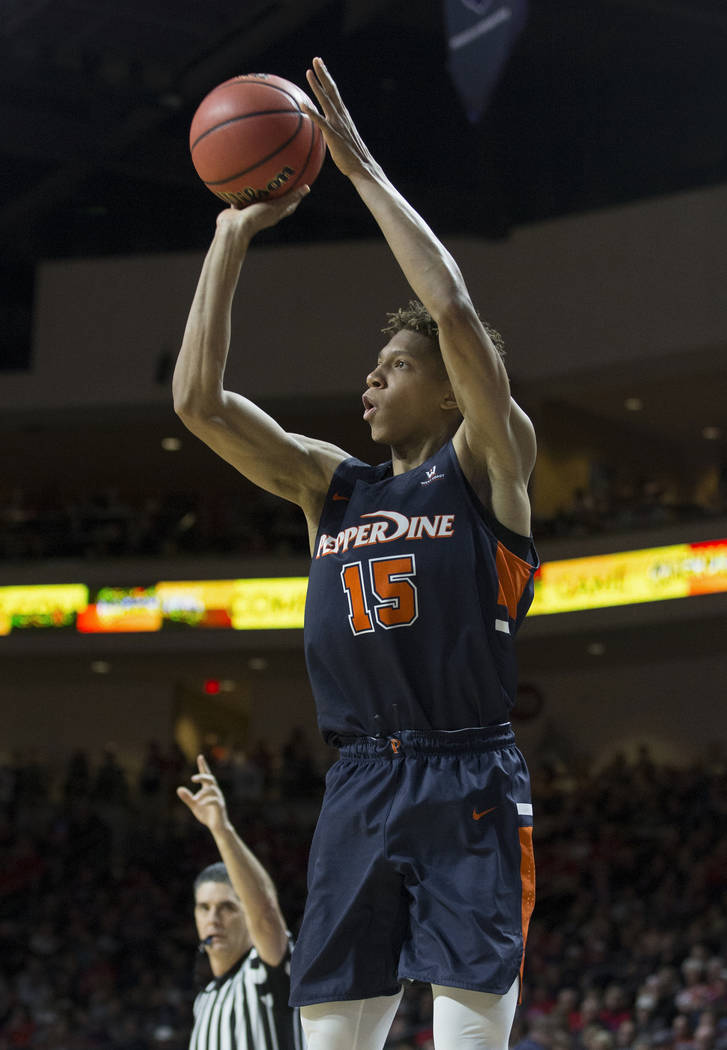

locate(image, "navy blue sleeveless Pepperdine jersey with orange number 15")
[[305, 441, 538, 742]]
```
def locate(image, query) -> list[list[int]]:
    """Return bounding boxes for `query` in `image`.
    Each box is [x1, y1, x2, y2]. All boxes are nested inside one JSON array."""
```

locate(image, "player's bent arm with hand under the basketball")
[[172, 196, 346, 530]]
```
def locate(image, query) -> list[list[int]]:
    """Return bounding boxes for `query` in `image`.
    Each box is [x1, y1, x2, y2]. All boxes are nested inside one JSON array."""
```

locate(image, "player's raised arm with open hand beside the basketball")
[[300, 59, 535, 533]]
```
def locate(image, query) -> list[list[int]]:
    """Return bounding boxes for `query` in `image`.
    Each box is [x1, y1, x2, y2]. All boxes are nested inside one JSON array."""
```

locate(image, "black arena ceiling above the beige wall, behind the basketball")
[[0, 0, 727, 279]]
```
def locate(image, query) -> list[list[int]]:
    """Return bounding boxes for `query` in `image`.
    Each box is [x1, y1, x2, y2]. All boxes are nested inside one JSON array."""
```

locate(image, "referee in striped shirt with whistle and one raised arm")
[[176, 755, 304, 1050]]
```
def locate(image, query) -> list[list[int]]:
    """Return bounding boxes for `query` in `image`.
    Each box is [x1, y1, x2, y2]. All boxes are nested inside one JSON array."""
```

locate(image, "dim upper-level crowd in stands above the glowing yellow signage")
[[0, 471, 727, 561]]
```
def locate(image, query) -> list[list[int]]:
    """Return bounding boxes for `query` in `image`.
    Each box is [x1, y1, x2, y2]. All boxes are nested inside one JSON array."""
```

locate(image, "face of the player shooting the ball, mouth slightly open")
[[362, 329, 451, 446]]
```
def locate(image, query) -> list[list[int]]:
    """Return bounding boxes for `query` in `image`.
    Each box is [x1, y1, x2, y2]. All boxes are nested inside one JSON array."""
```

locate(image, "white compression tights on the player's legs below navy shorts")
[[300, 978, 519, 1050]]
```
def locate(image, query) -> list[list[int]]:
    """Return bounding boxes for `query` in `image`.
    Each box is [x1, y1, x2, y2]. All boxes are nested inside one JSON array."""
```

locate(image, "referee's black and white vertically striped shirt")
[[189, 948, 305, 1050]]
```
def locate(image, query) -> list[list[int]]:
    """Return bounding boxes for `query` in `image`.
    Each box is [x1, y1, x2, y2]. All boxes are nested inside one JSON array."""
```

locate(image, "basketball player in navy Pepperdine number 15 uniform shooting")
[[174, 59, 537, 1050]]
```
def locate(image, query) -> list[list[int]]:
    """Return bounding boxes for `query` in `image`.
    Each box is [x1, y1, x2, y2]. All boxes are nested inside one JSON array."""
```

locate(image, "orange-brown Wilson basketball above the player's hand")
[[189, 72, 326, 207]]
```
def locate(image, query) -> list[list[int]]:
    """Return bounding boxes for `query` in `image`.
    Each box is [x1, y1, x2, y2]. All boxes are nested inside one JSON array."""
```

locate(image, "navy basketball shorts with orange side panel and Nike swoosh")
[[290, 723, 535, 1006]]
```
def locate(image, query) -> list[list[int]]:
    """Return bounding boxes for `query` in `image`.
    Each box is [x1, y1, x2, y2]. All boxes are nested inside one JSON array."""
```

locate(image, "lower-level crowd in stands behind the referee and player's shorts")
[[0, 732, 727, 1050]]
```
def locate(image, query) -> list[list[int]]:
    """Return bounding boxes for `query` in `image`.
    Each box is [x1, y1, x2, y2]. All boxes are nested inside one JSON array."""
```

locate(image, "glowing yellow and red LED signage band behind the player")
[[0, 540, 727, 635]]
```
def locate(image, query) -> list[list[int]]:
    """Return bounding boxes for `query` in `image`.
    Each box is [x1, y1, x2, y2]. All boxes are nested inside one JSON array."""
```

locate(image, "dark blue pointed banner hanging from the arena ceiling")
[[444, 0, 527, 124]]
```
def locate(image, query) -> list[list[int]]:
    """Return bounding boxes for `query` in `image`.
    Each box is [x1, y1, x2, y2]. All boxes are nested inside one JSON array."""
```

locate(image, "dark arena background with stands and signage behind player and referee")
[[0, 0, 727, 1050]]
